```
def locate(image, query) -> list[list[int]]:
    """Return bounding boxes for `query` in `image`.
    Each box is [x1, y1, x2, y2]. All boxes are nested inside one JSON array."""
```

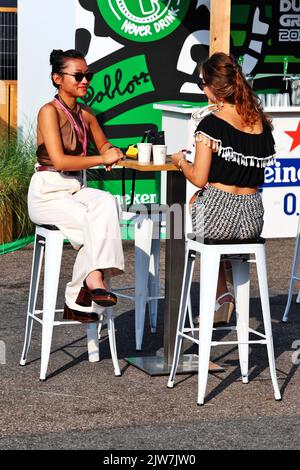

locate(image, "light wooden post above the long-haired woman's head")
[[209, 0, 231, 55]]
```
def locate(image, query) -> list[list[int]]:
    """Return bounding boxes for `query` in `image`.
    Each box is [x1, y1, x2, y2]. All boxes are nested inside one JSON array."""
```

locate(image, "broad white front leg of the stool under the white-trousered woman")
[[40, 232, 63, 380]]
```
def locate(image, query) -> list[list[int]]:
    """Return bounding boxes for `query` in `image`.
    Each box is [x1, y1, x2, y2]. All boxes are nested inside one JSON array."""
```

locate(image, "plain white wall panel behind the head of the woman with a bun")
[[18, 0, 77, 136]]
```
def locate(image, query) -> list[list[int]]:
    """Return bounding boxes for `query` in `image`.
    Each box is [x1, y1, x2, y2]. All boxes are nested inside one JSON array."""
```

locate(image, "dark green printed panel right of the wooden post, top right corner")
[[230, 0, 300, 93]]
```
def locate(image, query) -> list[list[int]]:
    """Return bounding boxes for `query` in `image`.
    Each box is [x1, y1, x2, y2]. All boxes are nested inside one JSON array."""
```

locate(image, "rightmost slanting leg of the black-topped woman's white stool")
[[256, 245, 281, 400]]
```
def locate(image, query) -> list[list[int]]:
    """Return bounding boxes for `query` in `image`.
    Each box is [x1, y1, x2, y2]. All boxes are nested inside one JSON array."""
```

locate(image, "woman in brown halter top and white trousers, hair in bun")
[[28, 50, 124, 322]]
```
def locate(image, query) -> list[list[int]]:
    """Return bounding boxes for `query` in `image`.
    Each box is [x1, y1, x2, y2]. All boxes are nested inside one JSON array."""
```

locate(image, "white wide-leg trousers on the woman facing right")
[[28, 171, 124, 314]]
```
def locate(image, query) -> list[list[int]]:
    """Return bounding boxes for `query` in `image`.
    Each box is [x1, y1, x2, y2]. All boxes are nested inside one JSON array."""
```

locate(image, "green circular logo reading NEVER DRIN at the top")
[[98, 0, 190, 42]]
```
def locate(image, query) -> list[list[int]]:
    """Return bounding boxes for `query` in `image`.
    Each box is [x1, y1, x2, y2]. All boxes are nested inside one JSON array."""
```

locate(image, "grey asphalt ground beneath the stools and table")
[[0, 239, 300, 450]]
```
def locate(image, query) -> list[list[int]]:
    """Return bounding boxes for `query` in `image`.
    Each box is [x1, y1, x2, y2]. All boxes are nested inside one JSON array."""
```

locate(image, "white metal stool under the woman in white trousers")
[[20, 225, 121, 380]]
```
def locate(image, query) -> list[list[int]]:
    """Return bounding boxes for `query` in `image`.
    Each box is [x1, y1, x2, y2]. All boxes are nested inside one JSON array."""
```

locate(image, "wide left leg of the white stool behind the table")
[[135, 218, 153, 351]]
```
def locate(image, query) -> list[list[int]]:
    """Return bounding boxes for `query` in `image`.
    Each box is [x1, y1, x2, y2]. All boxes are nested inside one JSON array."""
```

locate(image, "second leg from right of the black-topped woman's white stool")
[[232, 261, 250, 383]]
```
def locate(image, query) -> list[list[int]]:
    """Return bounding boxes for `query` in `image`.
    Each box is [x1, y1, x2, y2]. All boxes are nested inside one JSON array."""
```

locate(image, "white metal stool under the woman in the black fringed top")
[[168, 235, 281, 405]]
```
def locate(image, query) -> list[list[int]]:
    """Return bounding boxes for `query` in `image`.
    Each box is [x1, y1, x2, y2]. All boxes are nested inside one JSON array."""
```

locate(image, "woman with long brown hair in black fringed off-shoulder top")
[[173, 53, 275, 325]]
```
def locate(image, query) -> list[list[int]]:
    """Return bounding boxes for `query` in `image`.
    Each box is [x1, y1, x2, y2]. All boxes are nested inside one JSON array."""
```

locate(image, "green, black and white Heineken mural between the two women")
[[76, 0, 209, 222]]
